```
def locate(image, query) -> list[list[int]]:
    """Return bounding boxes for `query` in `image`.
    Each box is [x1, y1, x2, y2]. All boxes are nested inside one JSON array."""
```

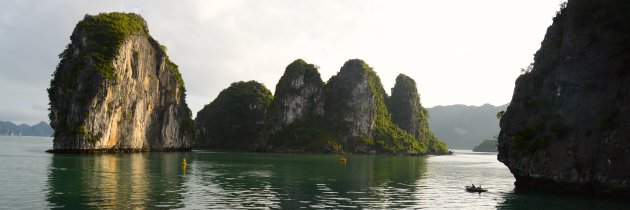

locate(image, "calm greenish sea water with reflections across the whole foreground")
[[0, 136, 630, 209]]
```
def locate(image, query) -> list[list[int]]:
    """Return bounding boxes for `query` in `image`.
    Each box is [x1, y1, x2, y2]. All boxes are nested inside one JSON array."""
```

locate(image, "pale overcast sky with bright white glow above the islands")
[[0, 0, 561, 123]]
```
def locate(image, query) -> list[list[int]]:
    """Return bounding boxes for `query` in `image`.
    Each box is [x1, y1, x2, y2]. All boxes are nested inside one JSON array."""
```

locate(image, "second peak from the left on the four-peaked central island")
[[265, 59, 334, 152]]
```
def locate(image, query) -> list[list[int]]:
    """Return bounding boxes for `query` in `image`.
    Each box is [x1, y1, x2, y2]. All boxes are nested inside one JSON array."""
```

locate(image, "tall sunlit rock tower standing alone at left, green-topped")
[[48, 13, 195, 152]]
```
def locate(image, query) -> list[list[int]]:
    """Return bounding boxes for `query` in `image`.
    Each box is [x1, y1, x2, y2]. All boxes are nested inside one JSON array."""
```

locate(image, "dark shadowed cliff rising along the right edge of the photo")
[[498, 0, 630, 195]]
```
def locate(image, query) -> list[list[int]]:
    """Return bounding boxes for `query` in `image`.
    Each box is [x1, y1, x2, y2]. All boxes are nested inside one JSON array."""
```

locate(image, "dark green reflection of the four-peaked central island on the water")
[[187, 153, 426, 209]]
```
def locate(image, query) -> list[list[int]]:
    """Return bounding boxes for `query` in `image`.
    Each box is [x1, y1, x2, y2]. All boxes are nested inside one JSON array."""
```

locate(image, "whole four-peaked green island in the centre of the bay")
[[195, 59, 448, 155]]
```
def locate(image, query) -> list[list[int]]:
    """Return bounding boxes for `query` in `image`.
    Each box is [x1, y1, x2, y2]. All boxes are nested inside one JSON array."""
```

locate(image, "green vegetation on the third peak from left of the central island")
[[325, 59, 448, 154]]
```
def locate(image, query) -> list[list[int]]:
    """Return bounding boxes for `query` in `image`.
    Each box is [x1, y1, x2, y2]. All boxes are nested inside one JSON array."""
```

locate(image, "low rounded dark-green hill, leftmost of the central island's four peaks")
[[195, 81, 273, 149]]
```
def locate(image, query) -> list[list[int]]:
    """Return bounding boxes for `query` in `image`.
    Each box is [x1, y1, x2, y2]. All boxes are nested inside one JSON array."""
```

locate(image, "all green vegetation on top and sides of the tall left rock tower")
[[47, 12, 196, 147]]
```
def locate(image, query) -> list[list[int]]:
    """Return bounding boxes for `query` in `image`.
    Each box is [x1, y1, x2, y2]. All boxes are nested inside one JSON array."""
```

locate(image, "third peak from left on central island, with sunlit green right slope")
[[324, 59, 447, 154]]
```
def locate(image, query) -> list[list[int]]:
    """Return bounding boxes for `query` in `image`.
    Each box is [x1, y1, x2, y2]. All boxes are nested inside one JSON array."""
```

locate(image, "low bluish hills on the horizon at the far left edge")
[[0, 121, 54, 137]]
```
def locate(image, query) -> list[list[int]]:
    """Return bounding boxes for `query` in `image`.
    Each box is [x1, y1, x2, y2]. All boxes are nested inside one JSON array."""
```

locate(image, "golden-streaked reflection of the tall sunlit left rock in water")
[[46, 153, 186, 209]]
